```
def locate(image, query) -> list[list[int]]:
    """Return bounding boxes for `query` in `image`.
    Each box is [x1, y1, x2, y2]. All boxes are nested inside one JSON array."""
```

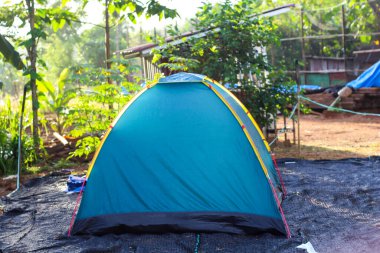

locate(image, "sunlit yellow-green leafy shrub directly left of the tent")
[[67, 60, 140, 157]]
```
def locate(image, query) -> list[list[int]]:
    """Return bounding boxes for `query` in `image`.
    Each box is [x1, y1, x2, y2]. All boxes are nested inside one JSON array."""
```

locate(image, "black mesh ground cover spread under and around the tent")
[[0, 157, 380, 253]]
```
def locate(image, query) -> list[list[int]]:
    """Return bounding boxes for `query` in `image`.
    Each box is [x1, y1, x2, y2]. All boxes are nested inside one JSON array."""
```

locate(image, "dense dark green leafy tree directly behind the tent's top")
[[154, 0, 295, 127]]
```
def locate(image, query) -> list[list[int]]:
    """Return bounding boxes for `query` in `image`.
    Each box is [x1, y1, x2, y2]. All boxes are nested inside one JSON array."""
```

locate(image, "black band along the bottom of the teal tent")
[[72, 212, 286, 235]]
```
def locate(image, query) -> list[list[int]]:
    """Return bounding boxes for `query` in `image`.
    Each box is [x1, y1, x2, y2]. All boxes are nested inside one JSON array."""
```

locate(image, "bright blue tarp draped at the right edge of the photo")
[[346, 61, 380, 89]]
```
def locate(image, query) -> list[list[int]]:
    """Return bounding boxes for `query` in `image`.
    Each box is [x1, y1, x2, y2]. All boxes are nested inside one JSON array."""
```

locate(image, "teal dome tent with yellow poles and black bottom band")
[[72, 73, 286, 234]]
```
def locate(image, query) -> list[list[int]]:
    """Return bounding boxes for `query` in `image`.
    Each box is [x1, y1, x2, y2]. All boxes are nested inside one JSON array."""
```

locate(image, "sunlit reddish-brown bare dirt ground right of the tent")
[[272, 113, 380, 160]]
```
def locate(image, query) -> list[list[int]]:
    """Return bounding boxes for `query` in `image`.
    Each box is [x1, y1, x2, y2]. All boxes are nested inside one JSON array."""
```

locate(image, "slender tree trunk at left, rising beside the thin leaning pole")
[[25, 0, 40, 150]]
